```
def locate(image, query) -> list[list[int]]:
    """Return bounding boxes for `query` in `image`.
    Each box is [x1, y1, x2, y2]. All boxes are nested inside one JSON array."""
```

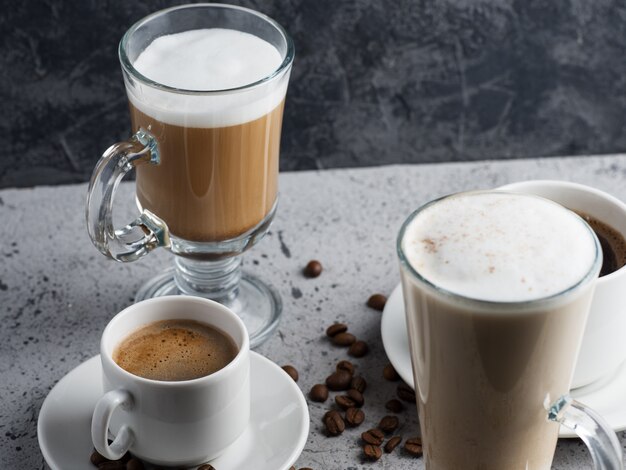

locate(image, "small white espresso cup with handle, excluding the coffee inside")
[[91, 296, 250, 466]]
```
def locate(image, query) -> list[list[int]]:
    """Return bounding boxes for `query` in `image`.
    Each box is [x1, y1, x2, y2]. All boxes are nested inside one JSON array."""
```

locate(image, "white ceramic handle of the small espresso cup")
[[91, 390, 135, 460]]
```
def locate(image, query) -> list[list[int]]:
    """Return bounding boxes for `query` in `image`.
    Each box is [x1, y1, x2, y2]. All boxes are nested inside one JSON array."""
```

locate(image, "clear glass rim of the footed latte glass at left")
[[118, 3, 295, 96]]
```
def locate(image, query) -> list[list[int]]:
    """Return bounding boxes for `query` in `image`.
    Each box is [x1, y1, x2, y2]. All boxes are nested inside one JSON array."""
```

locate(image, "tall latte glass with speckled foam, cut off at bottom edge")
[[398, 192, 622, 470]]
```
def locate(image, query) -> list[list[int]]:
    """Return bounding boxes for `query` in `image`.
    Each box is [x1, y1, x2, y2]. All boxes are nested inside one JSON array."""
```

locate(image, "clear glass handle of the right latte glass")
[[548, 395, 624, 470]]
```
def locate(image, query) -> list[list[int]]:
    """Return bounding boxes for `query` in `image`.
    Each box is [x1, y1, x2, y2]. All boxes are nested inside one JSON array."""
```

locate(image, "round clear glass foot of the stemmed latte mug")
[[135, 267, 283, 348]]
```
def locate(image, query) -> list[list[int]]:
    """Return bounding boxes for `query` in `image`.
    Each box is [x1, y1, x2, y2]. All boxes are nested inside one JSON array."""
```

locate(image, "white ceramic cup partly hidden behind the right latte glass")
[[498, 180, 626, 388]]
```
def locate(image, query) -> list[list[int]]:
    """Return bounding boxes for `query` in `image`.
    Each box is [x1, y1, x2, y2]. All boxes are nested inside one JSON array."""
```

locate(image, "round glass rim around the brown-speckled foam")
[[396, 190, 602, 310]]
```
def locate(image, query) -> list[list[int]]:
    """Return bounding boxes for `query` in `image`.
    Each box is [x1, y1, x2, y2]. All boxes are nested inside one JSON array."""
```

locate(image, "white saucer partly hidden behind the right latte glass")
[[380, 285, 626, 437]]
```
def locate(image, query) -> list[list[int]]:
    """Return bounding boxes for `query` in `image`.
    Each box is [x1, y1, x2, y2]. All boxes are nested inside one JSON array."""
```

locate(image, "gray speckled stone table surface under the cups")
[[0, 155, 626, 470]]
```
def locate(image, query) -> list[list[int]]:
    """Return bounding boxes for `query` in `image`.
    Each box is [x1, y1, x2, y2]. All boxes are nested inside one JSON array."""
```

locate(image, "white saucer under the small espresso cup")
[[37, 352, 309, 470]]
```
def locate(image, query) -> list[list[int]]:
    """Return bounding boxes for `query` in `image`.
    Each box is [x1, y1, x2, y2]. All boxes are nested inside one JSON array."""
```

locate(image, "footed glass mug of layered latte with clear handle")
[[87, 4, 294, 346]]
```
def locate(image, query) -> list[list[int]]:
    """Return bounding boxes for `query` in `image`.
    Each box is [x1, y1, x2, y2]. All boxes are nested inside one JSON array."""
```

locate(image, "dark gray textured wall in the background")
[[0, 0, 626, 187]]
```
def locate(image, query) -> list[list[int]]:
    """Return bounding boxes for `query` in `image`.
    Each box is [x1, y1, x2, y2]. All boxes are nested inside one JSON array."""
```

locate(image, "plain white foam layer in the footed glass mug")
[[126, 28, 289, 127]]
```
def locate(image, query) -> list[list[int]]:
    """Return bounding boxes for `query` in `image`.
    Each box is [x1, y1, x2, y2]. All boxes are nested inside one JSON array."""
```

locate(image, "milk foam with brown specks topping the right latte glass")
[[402, 192, 596, 302]]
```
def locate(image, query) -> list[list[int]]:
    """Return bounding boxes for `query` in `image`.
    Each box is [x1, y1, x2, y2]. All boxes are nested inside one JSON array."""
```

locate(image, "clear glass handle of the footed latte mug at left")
[[86, 129, 169, 261]]
